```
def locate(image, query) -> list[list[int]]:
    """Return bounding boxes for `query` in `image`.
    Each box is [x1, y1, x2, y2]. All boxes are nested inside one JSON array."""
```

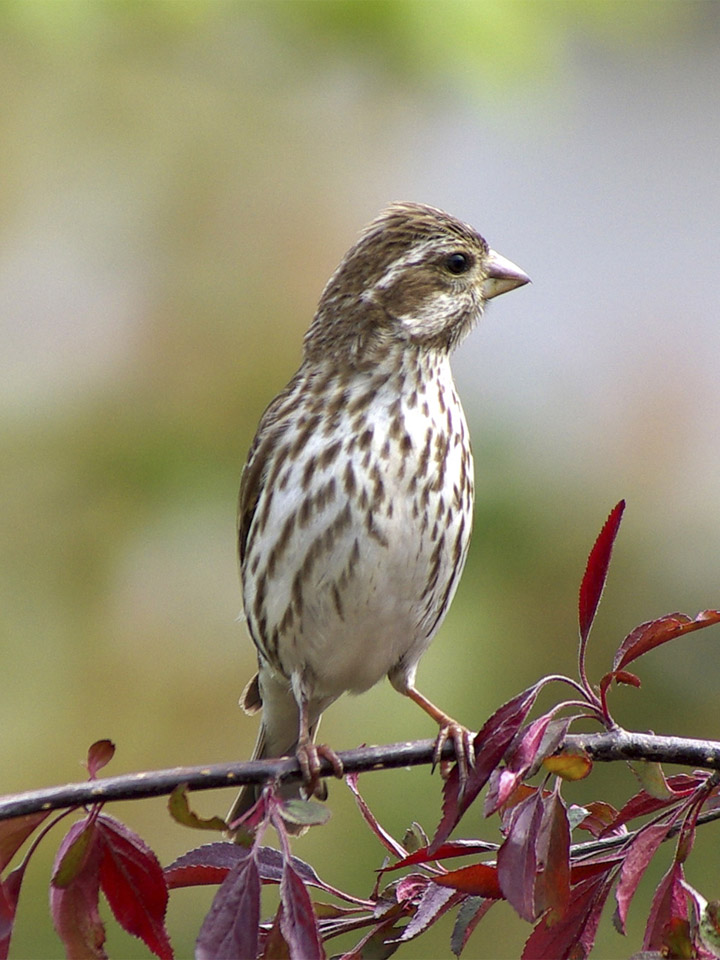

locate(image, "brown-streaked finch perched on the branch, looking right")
[[227, 202, 530, 836]]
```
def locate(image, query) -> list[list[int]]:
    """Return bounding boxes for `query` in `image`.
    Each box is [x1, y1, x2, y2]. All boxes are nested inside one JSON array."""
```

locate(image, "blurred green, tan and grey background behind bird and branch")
[[0, 0, 720, 958]]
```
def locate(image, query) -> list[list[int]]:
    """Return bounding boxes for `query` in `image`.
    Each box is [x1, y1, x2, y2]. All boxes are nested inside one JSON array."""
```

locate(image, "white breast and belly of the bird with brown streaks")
[[242, 367, 473, 696]]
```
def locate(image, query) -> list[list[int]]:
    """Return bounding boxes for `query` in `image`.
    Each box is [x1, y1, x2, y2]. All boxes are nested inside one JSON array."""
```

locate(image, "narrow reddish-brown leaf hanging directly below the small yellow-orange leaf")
[[535, 792, 570, 922]]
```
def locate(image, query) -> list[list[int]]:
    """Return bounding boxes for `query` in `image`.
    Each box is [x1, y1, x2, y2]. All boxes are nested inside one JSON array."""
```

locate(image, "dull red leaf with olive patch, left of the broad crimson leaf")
[[50, 820, 107, 960]]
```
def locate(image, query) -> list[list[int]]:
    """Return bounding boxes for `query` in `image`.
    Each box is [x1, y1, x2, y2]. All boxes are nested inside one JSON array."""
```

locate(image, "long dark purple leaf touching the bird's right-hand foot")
[[430, 681, 542, 851]]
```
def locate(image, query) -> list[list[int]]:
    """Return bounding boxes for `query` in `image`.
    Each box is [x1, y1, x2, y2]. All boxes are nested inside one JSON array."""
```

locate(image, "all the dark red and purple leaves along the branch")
[[0, 501, 720, 960]]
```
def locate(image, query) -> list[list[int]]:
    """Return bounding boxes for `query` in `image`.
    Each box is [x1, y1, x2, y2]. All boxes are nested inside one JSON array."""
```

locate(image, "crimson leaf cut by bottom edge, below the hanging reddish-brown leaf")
[[522, 876, 612, 960]]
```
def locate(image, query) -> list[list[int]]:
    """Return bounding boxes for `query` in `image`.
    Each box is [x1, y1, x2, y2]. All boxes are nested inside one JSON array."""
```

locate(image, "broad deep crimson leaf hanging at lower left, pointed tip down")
[[96, 814, 173, 960]]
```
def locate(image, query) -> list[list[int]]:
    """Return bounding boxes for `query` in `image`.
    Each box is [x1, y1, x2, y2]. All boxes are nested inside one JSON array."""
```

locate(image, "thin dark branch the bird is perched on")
[[0, 729, 720, 820]]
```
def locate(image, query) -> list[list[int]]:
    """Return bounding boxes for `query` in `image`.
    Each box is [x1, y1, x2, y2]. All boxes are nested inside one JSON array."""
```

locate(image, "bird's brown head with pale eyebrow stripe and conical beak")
[[305, 203, 530, 363]]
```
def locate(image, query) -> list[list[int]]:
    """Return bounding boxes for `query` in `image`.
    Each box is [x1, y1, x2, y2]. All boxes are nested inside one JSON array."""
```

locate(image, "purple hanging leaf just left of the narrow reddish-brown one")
[[497, 791, 543, 923]]
